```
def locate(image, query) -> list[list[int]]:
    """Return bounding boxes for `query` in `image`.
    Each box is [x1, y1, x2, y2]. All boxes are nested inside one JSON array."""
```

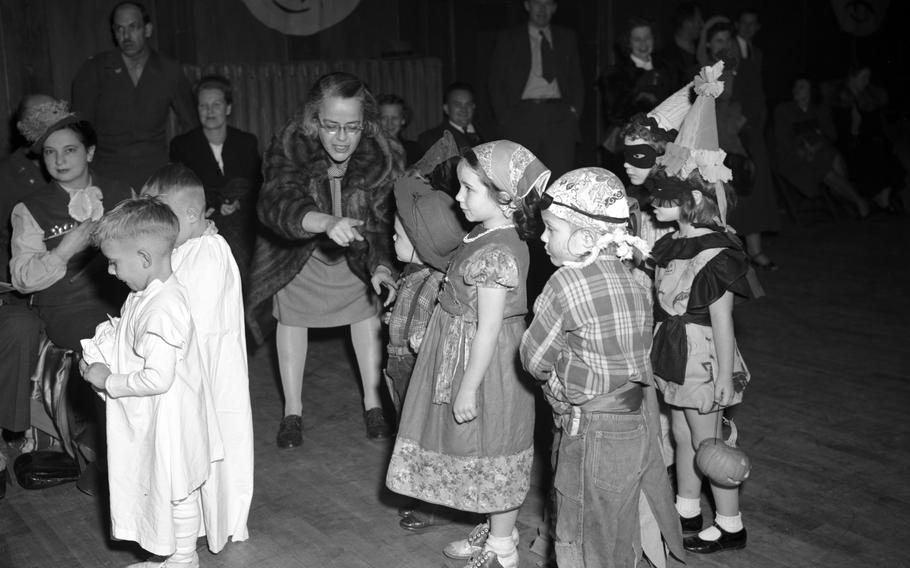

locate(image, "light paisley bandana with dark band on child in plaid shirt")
[[540, 168, 648, 268]]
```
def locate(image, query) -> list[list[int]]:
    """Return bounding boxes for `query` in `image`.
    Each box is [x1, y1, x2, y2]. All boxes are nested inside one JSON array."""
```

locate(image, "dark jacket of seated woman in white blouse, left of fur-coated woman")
[[170, 126, 262, 211]]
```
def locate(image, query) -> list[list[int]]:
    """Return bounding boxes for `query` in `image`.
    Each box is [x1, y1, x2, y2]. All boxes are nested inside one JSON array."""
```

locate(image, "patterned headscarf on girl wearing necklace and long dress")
[[473, 140, 550, 199]]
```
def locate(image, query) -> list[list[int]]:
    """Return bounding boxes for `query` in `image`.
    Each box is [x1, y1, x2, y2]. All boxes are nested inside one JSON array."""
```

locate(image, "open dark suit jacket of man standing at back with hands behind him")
[[490, 24, 585, 124]]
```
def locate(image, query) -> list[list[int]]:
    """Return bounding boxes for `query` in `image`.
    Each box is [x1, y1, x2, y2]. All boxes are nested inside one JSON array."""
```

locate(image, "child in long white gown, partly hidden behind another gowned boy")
[[142, 164, 253, 553]]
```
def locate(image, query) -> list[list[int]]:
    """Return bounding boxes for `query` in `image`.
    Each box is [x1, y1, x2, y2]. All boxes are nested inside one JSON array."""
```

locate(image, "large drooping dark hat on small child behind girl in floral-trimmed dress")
[[395, 175, 467, 272]]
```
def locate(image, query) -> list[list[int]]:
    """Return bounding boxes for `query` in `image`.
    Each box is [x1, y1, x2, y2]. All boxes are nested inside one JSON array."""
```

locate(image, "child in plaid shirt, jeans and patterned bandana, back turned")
[[520, 168, 683, 568]]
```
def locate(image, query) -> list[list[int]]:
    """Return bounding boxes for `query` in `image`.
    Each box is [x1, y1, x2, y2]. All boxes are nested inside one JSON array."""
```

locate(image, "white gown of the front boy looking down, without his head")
[[82, 276, 224, 556]]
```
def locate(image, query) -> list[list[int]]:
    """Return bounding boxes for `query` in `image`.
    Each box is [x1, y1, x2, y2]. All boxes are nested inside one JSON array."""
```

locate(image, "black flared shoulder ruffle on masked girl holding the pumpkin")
[[689, 249, 764, 310]]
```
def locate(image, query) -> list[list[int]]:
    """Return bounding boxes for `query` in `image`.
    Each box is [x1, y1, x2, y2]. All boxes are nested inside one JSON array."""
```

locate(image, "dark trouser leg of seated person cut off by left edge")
[[0, 304, 44, 432]]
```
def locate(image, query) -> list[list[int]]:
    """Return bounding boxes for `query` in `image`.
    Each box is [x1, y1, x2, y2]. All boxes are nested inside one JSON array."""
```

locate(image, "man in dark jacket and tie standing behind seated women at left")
[[73, 2, 196, 193]]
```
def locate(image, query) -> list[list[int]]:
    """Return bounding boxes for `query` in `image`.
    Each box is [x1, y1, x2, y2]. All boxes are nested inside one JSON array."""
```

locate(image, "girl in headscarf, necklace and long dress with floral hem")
[[386, 140, 550, 568]]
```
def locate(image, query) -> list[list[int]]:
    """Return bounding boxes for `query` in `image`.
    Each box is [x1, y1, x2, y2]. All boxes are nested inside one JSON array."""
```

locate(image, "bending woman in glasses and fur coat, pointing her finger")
[[247, 73, 404, 448]]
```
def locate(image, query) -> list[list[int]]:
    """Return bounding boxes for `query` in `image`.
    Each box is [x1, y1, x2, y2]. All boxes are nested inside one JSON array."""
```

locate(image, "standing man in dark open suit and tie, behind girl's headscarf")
[[490, 0, 584, 179]]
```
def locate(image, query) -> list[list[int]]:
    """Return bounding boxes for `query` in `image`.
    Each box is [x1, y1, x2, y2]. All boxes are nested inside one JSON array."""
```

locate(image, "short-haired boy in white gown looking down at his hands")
[[81, 199, 223, 568]]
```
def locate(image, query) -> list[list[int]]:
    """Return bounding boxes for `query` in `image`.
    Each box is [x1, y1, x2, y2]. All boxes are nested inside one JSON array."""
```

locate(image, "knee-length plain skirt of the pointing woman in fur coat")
[[272, 253, 380, 327]]
